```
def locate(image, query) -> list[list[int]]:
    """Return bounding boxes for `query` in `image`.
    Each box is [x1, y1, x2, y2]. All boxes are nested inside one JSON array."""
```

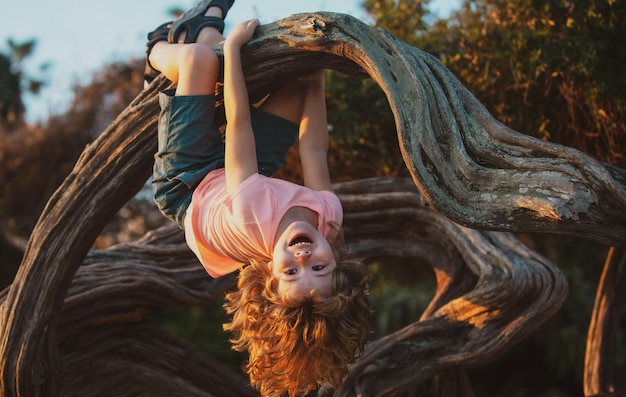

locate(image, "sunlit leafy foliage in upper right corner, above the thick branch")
[[417, 0, 626, 167]]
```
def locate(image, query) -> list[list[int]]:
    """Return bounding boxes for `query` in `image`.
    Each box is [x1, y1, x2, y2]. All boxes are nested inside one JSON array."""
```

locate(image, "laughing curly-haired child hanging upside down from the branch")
[[147, 0, 369, 396]]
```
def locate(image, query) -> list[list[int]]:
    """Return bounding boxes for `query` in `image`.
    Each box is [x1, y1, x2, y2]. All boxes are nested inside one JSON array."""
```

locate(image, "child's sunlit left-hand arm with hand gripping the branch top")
[[224, 19, 259, 193]]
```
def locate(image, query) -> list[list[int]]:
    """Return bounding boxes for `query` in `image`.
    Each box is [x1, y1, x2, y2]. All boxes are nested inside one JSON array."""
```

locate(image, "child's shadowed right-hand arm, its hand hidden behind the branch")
[[299, 71, 332, 191]]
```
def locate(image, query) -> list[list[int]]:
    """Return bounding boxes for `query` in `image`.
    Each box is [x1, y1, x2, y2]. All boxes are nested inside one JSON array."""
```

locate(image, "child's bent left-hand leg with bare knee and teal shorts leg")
[[149, 12, 224, 227]]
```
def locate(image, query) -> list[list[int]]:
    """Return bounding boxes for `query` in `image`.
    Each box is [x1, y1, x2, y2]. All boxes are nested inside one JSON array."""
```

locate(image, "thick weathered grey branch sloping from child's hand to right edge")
[[264, 14, 626, 245]]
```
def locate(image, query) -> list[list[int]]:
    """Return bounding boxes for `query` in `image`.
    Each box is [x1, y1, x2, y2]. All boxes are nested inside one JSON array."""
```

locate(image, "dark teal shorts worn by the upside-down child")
[[152, 90, 298, 228]]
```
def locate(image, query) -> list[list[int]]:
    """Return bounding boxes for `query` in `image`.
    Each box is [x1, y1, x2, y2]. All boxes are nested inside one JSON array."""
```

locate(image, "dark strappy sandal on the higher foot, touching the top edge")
[[167, 0, 235, 43]]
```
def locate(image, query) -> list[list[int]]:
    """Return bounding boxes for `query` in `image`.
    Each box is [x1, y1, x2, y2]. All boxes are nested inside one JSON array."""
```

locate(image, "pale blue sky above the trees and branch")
[[0, 0, 461, 122]]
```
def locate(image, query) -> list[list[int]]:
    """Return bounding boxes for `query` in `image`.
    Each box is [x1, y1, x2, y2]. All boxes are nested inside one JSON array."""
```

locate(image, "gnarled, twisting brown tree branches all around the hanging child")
[[0, 13, 626, 397]]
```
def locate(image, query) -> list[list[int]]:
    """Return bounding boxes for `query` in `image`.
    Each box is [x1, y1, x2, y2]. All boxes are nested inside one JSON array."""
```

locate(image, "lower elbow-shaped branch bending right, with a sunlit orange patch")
[[337, 180, 567, 396]]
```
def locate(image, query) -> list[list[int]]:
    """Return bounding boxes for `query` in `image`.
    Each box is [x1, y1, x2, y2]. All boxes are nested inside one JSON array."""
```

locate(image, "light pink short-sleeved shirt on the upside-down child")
[[185, 168, 343, 277]]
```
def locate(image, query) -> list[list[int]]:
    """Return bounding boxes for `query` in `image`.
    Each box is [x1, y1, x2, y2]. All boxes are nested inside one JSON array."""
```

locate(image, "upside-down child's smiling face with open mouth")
[[270, 222, 337, 299]]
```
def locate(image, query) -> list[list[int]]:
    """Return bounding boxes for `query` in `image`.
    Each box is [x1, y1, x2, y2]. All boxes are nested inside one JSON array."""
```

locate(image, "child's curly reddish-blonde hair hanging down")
[[224, 230, 370, 397]]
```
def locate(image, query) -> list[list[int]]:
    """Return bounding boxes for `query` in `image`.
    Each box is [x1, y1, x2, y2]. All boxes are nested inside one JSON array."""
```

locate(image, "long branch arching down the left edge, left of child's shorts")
[[0, 82, 163, 396]]
